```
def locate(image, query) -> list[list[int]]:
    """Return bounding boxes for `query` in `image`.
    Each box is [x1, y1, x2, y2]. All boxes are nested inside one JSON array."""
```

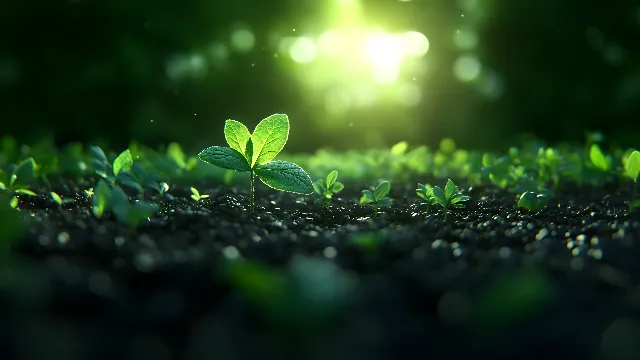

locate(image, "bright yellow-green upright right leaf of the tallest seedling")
[[251, 114, 289, 168]]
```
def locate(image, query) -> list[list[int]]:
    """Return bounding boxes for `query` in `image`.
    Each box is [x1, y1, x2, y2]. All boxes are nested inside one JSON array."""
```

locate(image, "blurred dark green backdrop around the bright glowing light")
[[0, 0, 640, 151]]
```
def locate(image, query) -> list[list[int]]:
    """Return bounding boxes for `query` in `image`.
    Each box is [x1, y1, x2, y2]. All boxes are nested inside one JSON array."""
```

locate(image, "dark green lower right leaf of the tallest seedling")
[[254, 161, 313, 194]]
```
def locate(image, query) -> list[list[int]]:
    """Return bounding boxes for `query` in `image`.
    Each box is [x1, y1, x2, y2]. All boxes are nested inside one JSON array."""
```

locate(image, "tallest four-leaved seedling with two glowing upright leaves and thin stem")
[[198, 114, 313, 211]]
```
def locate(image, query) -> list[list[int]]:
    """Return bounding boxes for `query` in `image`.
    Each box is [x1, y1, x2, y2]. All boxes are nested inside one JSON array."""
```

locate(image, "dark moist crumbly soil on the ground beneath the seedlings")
[[0, 180, 640, 360]]
